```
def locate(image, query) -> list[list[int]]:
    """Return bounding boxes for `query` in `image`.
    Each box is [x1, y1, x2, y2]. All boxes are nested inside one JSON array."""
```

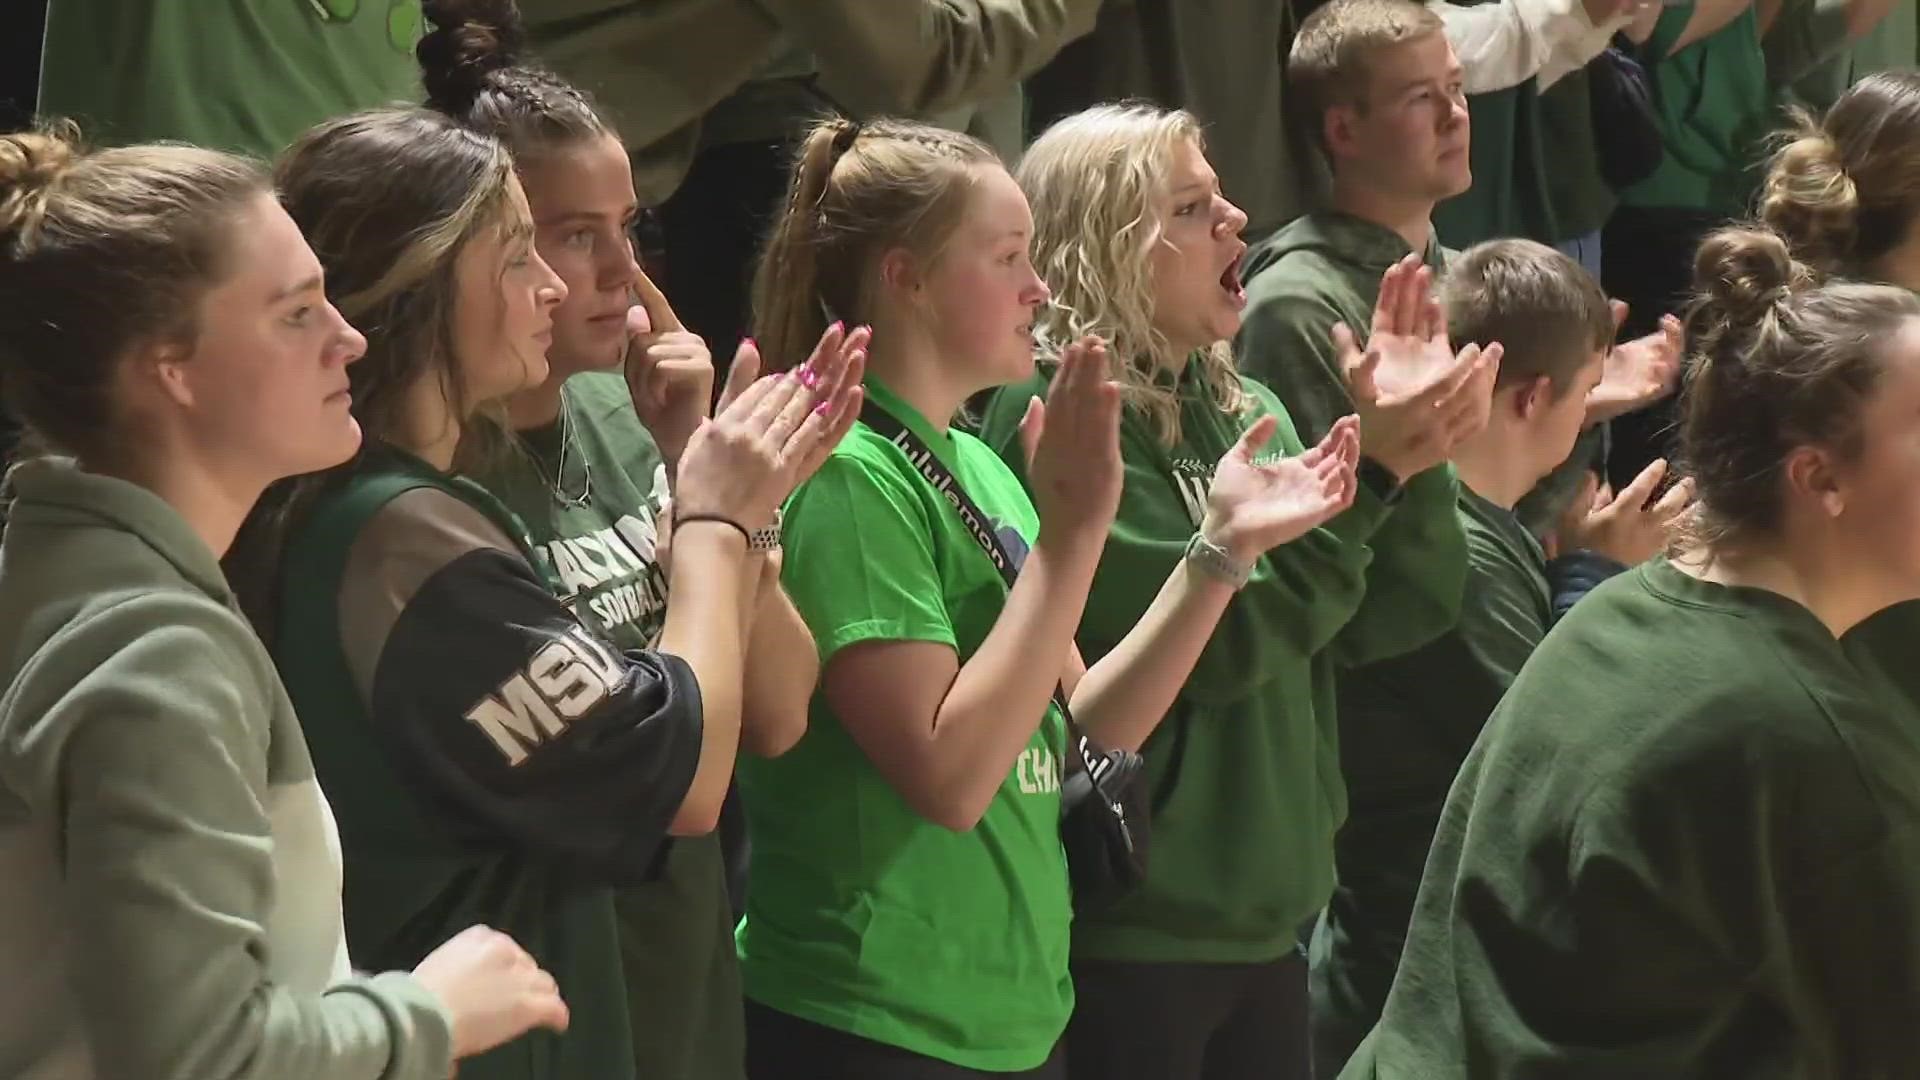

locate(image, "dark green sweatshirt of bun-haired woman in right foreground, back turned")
[[1342, 559, 1920, 1080]]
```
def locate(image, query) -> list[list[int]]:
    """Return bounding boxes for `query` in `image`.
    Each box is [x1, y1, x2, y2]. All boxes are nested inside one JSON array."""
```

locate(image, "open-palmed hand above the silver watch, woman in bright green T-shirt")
[[1200, 417, 1359, 563]]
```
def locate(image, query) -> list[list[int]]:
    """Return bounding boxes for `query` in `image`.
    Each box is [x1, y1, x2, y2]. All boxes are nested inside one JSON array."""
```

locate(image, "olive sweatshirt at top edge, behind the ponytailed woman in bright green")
[[524, 0, 1100, 206]]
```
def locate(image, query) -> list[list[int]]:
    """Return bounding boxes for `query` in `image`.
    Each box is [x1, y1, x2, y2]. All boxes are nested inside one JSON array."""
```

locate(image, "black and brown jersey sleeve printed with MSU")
[[338, 488, 701, 884]]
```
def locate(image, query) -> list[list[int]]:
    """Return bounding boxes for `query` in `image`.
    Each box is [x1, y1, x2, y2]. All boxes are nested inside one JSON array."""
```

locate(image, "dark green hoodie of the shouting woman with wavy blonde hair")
[[983, 359, 1459, 963]]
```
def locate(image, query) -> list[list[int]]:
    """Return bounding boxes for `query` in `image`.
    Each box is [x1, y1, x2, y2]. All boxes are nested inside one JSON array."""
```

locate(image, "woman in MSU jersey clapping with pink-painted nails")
[[228, 110, 851, 1080]]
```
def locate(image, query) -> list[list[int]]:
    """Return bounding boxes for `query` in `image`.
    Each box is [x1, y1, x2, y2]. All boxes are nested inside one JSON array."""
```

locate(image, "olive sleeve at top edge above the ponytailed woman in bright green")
[[760, 0, 1100, 115]]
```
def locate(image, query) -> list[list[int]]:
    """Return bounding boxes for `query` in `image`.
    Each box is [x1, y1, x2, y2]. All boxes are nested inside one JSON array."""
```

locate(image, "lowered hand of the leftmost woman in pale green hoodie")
[[413, 914, 568, 1059]]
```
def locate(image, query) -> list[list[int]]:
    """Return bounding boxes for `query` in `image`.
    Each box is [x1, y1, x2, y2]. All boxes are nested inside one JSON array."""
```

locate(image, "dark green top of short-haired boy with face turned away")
[[1311, 484, 1622, 1063]]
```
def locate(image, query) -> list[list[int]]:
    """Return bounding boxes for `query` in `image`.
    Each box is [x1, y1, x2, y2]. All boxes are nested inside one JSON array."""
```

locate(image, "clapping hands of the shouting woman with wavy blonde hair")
[[1332, 256, 1501, 480]]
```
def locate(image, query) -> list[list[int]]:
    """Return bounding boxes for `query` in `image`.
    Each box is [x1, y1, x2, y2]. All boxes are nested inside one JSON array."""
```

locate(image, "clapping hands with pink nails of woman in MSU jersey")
[[674, 328, 866, 528]]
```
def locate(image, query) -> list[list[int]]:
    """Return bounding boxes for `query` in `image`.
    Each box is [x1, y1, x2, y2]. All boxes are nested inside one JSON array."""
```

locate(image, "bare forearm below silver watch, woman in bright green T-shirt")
[[1073, 559, 1233, 749]]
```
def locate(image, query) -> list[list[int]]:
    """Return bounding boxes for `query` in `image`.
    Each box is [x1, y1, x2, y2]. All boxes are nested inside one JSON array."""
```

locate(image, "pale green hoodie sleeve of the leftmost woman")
[[36, 601, 451, 1080]]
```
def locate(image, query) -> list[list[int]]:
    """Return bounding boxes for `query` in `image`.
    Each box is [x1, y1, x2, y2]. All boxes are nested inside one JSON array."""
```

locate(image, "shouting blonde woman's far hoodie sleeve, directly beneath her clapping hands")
[[1334, 465, 1467, 667]]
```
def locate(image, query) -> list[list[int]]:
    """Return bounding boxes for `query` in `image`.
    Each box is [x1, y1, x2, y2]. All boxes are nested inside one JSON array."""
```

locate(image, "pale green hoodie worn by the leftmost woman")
[[0, 459, 451, 1080]]
